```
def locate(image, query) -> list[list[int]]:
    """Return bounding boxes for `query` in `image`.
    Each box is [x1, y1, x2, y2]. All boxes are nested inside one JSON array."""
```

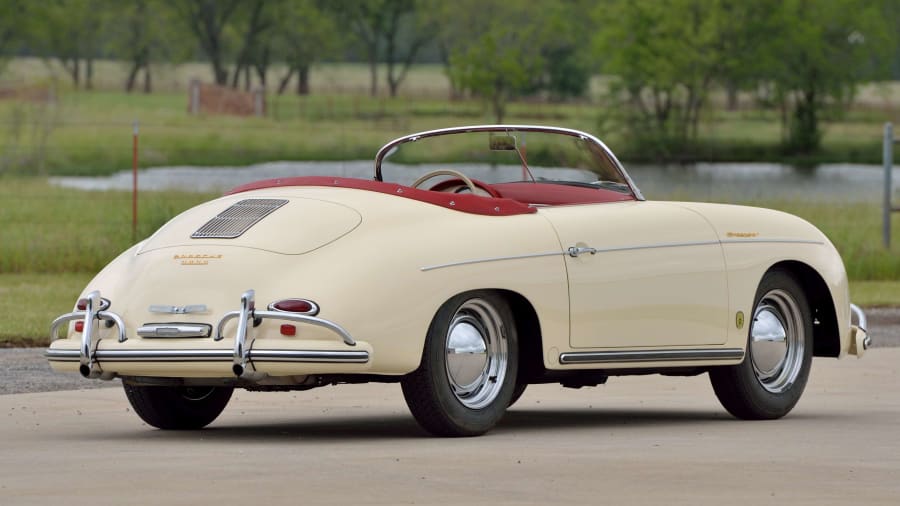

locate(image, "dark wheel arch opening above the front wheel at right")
[[769, 260, 841, 357]]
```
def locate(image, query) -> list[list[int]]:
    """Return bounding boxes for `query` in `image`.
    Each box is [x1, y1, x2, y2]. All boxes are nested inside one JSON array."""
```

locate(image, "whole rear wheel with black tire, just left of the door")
[[401, 292, 518, 436]]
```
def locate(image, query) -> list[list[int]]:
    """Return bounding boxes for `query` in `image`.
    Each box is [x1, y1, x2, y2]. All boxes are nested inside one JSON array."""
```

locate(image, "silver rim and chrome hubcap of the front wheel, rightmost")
[[750, 290, 806, 394]]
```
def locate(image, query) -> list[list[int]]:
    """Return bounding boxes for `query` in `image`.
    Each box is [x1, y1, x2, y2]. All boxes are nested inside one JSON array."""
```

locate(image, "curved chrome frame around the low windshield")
[[375, 125, 645, 200]]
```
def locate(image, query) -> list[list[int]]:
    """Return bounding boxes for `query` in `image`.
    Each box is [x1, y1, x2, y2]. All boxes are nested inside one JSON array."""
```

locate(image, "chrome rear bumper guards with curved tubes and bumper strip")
[[46, 290, 369, 378]]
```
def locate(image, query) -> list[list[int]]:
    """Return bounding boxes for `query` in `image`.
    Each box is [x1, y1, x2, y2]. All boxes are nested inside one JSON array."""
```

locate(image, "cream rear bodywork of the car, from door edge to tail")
[[52, 187, 568, 376]]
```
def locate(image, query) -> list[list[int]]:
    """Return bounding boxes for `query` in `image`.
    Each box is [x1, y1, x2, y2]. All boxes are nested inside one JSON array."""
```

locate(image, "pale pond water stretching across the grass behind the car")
[[51, 160, 900, 203]]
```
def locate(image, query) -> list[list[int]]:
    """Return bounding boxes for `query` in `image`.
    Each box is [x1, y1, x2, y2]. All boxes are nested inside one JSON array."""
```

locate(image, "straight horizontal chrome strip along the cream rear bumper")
[[44, 349, 369, 364]]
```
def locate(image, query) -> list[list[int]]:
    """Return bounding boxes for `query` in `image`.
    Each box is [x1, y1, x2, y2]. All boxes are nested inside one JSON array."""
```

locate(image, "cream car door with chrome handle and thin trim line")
[[540, 202, 728, 348]]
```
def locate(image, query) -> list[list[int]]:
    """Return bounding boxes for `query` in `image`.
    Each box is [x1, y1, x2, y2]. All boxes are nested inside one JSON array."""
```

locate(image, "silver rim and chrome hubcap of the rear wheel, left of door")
[[445, 299, 507, 409]]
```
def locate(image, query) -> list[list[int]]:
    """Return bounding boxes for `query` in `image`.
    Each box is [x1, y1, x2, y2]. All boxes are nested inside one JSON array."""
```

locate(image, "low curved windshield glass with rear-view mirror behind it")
[[381, 129, 632, 194]]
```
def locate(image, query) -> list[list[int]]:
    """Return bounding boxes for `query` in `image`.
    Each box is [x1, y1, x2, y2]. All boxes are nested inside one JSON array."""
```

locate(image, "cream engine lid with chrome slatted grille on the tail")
[[138, 195, 362, 255]]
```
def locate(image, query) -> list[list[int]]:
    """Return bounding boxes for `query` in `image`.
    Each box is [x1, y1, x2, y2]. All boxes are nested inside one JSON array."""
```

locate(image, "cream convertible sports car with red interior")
[[47, 125, 869, 436]]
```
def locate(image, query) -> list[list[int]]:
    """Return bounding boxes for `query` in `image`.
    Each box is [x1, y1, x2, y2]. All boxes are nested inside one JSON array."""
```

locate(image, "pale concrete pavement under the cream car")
[[0, 348, 900, 506]]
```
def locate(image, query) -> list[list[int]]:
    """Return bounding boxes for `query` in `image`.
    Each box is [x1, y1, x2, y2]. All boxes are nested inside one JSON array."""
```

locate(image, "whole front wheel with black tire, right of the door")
[[709, 270, 813, 420]]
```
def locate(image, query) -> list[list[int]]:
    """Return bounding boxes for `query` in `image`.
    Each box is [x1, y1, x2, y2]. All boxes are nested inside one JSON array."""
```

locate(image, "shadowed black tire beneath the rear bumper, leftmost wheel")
[[123, 382, 234, 430]]
